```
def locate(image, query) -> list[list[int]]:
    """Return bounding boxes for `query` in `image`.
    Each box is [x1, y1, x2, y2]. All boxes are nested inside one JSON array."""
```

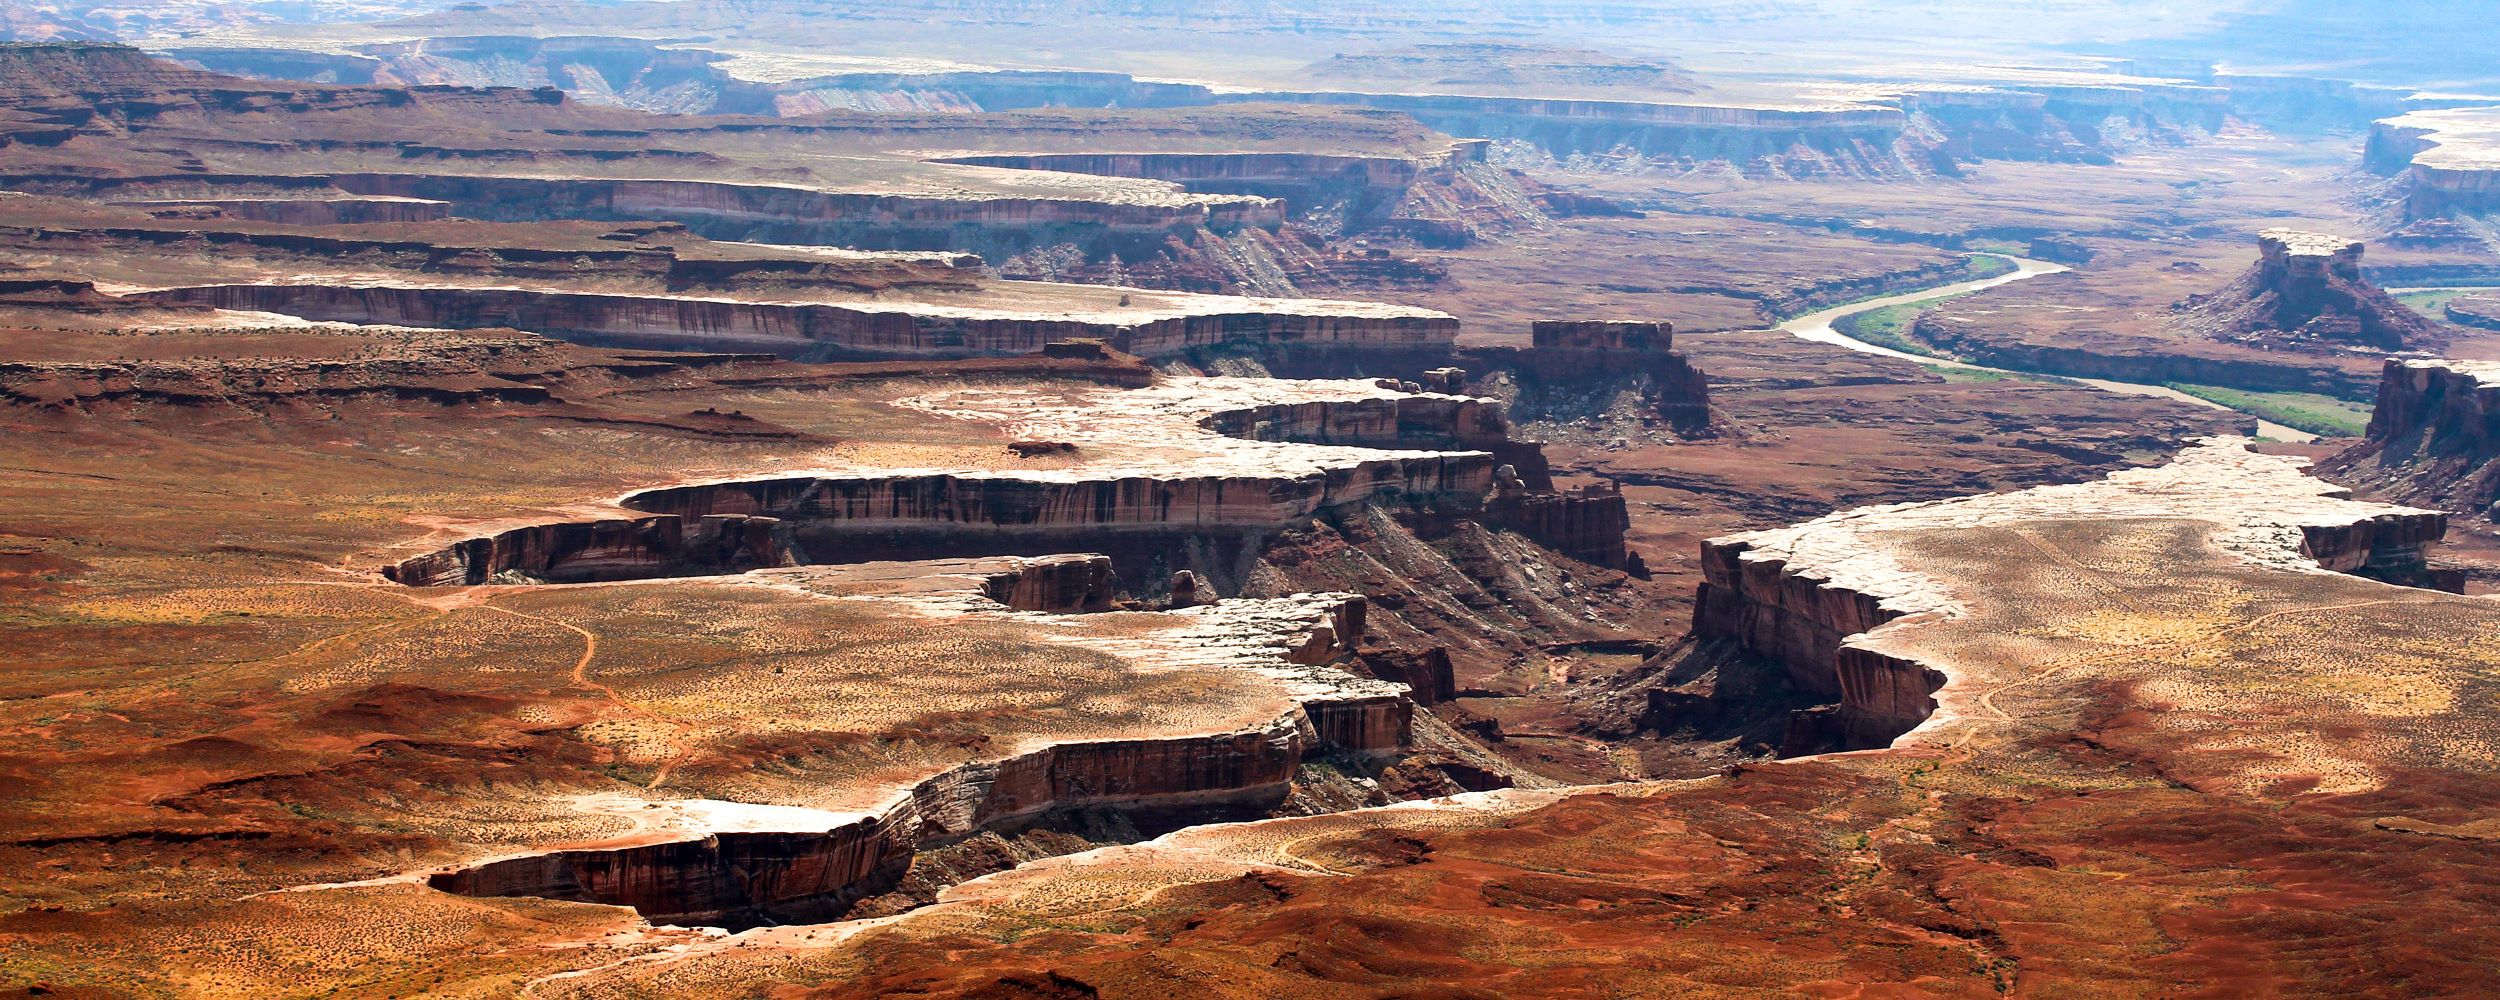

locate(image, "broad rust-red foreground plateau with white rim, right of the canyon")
[[542, 440, 2500, 998]]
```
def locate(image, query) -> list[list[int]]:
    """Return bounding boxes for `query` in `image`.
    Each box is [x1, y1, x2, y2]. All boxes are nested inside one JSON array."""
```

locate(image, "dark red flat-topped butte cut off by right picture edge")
[[2320, 358, 2500, 518]]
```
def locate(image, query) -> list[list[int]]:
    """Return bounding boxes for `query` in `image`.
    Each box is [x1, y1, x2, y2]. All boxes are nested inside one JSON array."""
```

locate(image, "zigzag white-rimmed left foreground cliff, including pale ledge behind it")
[[425, 555, 1413, 928]]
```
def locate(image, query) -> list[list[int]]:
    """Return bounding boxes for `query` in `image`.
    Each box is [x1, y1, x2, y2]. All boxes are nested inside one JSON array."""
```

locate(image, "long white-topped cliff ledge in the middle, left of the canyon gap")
[[385, 378, 1520, 585]]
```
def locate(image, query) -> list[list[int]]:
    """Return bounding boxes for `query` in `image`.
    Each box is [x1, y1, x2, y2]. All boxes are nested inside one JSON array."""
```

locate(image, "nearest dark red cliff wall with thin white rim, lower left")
[[428, 585, 1413, 930]]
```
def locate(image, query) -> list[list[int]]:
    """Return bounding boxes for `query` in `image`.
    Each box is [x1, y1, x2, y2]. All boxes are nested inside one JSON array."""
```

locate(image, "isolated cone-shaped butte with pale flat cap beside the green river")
[[2170, 230, 2443, 350]]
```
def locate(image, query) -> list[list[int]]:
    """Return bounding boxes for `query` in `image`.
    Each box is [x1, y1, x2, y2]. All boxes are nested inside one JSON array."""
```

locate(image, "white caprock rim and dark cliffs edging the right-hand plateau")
[[1693, 438, 2448, 748]]
